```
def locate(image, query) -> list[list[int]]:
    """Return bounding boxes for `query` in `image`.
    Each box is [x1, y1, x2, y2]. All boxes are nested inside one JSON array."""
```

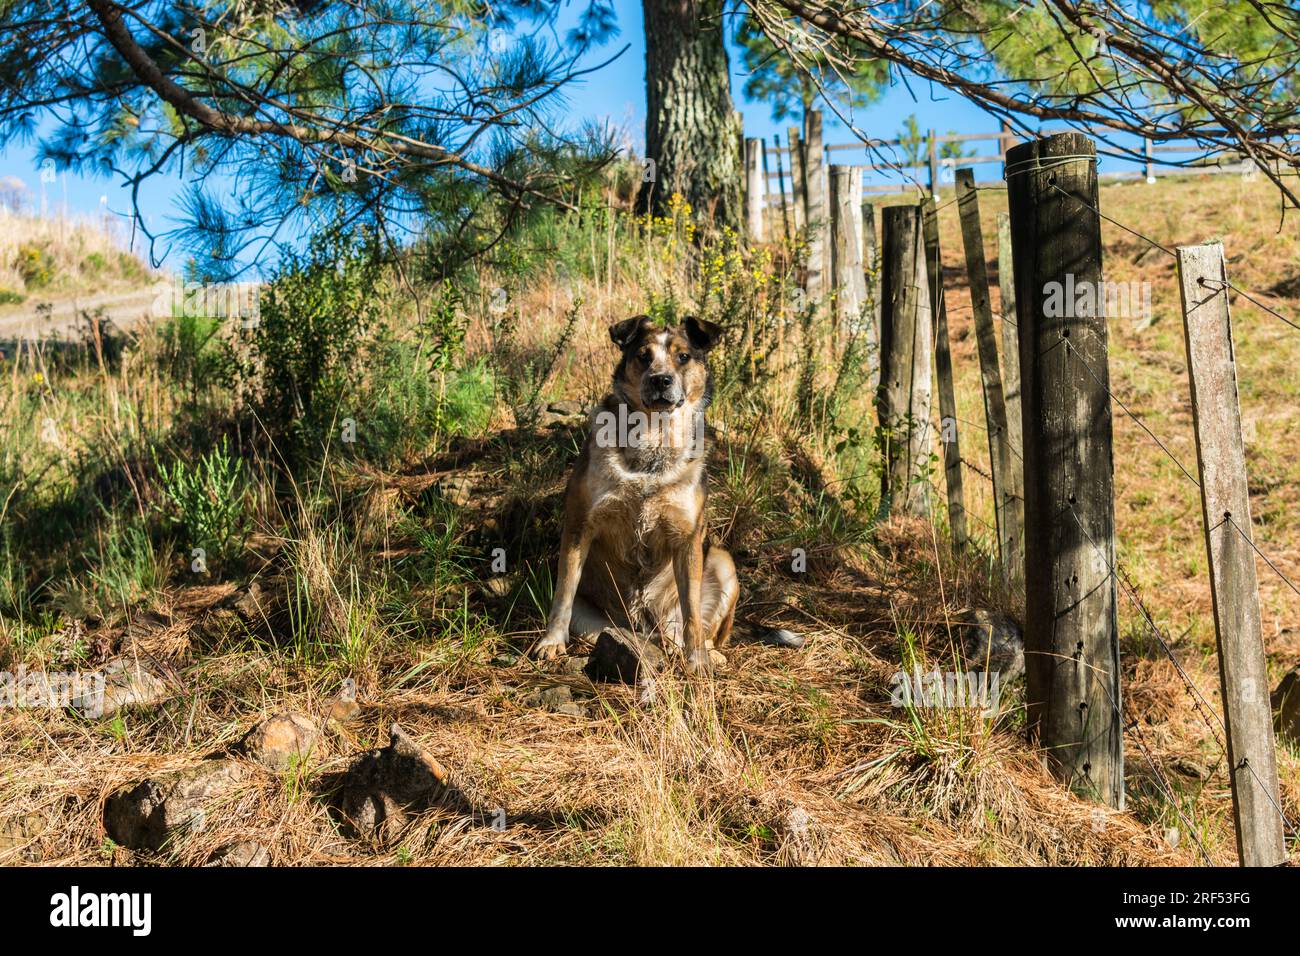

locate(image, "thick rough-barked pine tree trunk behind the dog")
[[640, 0, 742, 232]]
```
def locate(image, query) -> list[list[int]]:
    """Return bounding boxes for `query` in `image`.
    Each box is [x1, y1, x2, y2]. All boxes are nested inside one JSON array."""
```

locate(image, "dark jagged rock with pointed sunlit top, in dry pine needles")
[[339, 723, 450, 840]]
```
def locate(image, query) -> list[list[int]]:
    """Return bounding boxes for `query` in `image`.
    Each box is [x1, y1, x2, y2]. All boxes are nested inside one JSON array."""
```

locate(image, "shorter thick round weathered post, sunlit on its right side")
[[878, 206, 931, 516]]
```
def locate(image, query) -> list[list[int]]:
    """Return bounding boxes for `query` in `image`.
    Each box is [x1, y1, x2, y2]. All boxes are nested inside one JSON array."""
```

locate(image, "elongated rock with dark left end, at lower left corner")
[[104, 758, 247, 851]]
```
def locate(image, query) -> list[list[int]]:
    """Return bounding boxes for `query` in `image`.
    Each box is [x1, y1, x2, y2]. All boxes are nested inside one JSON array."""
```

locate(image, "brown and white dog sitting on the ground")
[[537, 316, 740, 674]]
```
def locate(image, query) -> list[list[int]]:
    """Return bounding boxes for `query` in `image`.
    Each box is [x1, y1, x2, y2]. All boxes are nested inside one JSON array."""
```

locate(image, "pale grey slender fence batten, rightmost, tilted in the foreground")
[[1178, 242, 1287, 866]]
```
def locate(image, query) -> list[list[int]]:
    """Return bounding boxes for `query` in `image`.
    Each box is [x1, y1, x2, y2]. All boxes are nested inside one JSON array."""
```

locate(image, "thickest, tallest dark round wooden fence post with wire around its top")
[[1006, 133, 1125, 808]]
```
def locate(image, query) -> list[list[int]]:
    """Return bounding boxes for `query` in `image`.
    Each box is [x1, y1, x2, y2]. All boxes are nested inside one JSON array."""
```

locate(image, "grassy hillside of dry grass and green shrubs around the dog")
[[0, 179, 1300, 865]]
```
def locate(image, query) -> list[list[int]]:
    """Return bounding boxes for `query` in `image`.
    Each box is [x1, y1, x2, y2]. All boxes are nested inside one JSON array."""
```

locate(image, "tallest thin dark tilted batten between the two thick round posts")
[[957, 166, 1024, 591]]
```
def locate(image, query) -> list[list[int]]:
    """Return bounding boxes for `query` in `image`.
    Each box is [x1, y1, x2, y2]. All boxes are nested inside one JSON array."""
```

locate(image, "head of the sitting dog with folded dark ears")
[[610, 315, 723, 411]]
